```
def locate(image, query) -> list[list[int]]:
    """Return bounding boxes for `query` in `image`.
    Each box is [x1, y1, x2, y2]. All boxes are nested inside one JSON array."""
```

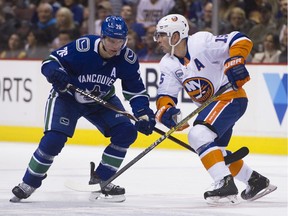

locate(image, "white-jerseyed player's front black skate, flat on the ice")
[[204, 175, 239, 205]]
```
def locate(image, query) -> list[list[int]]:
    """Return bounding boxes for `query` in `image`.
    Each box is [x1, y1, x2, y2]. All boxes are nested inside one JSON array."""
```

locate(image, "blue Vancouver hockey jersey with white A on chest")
[[42, 35, 149, 112]]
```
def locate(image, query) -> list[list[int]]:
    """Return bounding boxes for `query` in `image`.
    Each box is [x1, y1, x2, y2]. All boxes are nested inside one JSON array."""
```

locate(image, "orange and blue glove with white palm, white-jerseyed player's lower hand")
[[156, 105, 189, 131]]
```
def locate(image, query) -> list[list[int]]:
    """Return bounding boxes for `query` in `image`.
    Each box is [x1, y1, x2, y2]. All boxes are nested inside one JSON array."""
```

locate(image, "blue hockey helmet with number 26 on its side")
[[101, 16, 128, 40]]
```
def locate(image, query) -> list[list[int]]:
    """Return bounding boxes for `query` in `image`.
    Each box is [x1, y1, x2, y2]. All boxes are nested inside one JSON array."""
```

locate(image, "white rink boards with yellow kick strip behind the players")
[[0, 60, 288, 155]]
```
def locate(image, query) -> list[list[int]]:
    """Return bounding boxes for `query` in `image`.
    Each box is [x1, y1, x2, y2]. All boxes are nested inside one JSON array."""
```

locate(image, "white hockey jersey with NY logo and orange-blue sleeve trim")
[[158, 31, 252, 106]]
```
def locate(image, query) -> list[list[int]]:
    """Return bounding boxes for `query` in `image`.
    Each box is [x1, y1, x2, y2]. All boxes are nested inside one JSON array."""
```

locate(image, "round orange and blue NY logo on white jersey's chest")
[[183, 77, 214, 103]]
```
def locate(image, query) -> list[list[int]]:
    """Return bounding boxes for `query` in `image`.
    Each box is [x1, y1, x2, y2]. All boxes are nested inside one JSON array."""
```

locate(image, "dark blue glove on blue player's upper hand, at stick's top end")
[[46, 68, 70, 93]]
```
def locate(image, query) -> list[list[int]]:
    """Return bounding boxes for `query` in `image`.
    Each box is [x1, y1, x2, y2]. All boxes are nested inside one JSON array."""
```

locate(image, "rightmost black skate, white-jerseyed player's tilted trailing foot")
[[241, 171, 277, 201]]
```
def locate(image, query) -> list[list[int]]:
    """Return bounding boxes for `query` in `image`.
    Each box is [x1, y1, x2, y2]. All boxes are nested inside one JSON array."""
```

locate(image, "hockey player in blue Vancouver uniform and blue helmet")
[[10, 16, 155, 202]]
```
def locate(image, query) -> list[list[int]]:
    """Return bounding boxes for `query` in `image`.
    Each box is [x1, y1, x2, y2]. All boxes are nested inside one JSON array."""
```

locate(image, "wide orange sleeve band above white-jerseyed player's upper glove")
[[229, 40, 253, 59]]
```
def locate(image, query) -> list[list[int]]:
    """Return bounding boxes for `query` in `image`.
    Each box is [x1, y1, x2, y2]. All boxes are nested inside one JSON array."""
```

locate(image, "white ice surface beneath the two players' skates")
[[0, 142, 288, 216]]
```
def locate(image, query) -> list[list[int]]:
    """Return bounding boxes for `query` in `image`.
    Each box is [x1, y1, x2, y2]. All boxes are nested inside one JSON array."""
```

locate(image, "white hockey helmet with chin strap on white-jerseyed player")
[[154, 14, 189, 55]]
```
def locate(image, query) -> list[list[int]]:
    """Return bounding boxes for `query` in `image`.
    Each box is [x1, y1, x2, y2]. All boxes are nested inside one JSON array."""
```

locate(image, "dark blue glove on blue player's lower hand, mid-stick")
[[135, 108, 156, 135]]
